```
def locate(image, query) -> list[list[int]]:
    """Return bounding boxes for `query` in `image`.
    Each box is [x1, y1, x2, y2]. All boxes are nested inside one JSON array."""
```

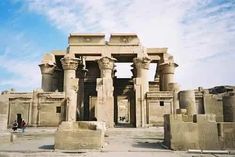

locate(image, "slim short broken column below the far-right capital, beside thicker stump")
[[168, 83, 180, 114]]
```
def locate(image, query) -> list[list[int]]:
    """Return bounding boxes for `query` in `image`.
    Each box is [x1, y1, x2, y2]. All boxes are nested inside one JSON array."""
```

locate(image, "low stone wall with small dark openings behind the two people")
[[5, 91, 65, 127]]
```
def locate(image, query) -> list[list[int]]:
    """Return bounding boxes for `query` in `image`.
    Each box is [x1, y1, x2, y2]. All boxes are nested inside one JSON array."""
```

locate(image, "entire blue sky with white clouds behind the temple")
[[0, 0, 235, 91]]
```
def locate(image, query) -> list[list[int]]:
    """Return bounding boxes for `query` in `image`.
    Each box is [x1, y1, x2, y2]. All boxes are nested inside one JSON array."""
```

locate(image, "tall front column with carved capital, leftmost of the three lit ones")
[[61, 54, 78, 122]]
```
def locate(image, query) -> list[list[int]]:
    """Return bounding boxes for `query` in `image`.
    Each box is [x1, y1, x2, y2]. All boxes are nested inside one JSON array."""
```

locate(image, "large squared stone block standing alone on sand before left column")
[[55, 121, 105, 150]]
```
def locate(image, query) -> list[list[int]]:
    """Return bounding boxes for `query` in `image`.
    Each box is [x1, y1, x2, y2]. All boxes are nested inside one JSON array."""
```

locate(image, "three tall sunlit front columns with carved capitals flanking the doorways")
[[56, 54, 150, 127]]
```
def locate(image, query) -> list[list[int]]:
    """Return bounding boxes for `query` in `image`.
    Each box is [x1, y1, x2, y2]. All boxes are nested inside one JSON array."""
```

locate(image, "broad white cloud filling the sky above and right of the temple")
[[18, 0, 235, 88]]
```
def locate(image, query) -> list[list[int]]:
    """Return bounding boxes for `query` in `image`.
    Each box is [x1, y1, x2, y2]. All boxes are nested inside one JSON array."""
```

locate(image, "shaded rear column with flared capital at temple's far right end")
[[159, 62, 178, 91]]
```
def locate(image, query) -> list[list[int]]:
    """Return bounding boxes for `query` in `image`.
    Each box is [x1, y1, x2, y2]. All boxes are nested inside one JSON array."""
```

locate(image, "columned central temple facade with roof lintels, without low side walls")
[[39, 34, 179, 127]]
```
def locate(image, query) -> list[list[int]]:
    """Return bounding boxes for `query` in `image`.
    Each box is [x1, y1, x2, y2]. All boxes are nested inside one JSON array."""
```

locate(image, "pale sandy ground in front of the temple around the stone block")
[[0, 127, 235, 157]]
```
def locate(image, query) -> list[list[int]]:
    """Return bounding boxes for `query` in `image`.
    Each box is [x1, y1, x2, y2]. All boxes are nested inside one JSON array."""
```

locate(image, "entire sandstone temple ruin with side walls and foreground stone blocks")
[[0, 33, 235, 150]]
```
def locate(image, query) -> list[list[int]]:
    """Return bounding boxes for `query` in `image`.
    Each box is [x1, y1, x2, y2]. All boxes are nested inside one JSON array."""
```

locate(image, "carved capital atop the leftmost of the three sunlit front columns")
[[60, 54, 79, 70]]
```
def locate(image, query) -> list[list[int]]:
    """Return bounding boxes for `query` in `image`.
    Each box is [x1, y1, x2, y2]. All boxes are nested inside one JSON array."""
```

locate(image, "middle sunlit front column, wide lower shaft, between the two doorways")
[[95, 57, 115, 127]]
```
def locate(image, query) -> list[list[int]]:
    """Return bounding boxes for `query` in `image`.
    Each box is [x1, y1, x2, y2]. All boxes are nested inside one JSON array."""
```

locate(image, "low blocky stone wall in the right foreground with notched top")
[[164, 114, 235, 150]]
